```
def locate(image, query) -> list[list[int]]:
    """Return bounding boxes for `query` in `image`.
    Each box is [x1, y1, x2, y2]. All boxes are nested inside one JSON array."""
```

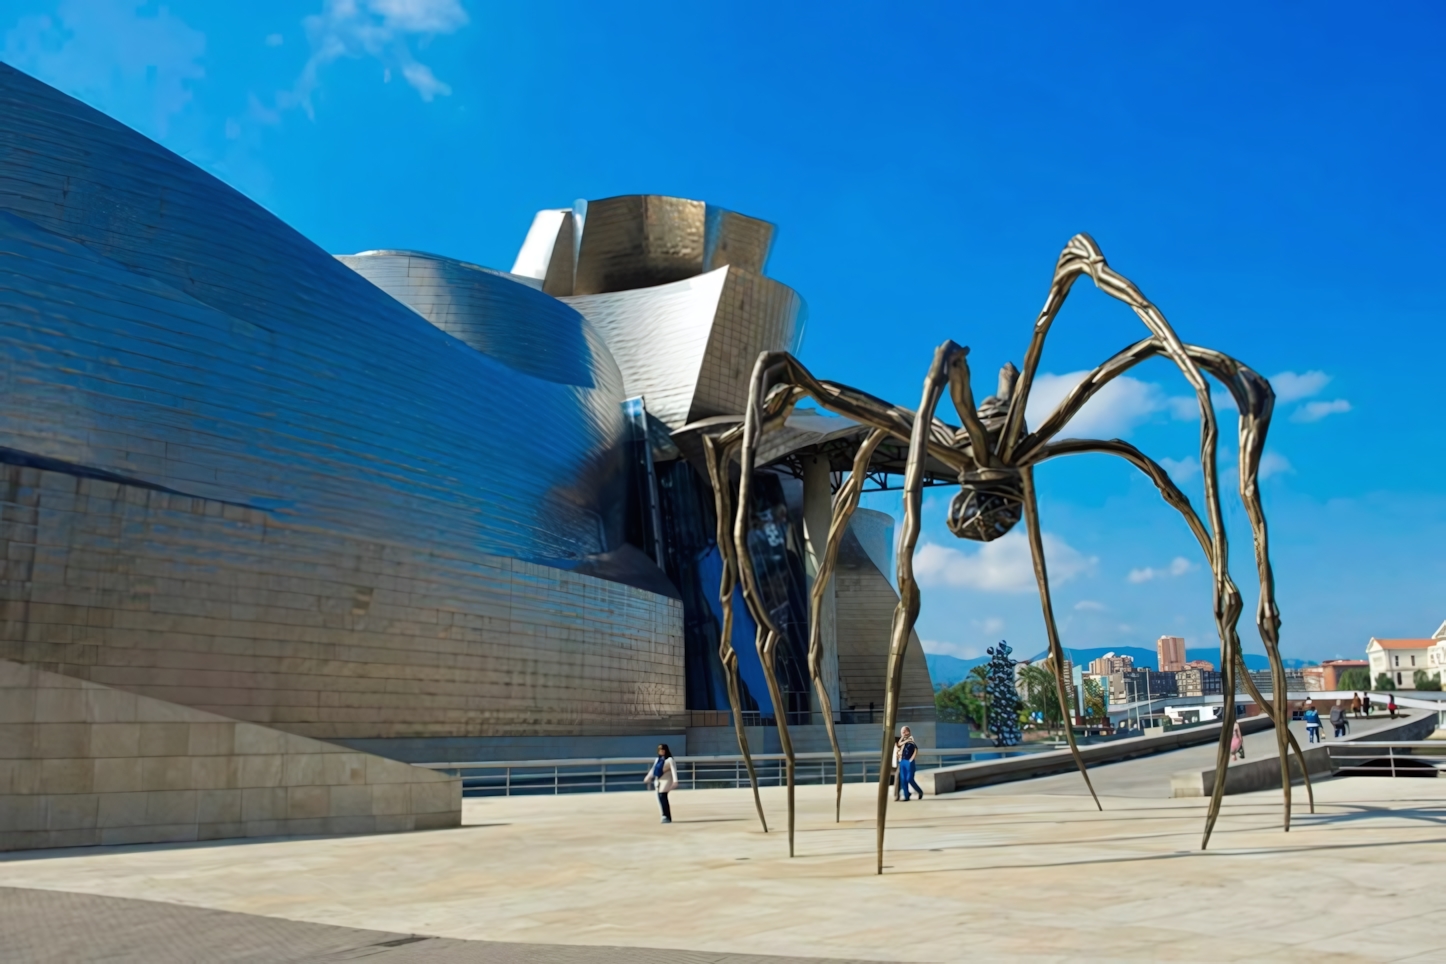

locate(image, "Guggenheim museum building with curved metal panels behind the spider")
[[0, 65, 934, 769]]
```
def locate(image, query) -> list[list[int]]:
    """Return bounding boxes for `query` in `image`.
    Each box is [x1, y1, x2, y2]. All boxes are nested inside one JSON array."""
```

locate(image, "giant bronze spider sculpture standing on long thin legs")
[[703, 234, 1314, 873]]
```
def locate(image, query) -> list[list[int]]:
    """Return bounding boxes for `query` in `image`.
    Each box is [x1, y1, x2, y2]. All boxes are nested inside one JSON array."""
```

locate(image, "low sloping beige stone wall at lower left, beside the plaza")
[[0, 660, 461, 851]]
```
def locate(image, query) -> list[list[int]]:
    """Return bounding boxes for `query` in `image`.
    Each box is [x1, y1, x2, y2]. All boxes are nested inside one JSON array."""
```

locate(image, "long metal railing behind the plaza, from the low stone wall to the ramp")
[[416, 743, 1057, 796]]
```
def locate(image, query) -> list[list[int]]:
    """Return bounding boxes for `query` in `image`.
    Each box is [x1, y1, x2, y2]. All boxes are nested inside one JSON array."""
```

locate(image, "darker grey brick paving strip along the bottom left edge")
[[0, 887, 879, 964]]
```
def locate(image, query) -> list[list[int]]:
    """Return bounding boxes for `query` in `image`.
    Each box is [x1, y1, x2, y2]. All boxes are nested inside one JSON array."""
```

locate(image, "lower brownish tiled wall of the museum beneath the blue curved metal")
[[0, 464, 685, 739]]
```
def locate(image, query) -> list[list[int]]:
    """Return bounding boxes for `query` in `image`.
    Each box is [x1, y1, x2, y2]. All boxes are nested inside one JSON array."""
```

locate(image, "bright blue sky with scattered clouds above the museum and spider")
[[0, 0, 1446, 659]]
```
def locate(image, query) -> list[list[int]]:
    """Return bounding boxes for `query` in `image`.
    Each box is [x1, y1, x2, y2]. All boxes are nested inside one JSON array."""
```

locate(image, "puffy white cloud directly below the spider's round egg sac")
[[914, 532, 1098, 593]]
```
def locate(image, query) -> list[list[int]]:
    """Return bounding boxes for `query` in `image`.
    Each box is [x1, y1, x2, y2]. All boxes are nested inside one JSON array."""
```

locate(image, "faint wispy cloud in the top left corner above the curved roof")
[[0, 0, 205, 139]]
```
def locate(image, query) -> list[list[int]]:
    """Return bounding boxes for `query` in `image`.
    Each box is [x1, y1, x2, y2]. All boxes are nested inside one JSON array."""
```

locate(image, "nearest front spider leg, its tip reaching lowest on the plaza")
[[875, 341, 964, 874]]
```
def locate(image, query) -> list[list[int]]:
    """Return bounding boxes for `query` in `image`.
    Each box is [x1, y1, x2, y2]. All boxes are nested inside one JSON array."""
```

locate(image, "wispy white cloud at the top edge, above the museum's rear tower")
[[290, 0, 467, 117]]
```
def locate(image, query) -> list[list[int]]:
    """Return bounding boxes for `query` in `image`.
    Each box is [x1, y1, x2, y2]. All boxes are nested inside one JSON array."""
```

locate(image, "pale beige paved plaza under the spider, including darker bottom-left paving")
[[0, 757, 1446, 964]]
